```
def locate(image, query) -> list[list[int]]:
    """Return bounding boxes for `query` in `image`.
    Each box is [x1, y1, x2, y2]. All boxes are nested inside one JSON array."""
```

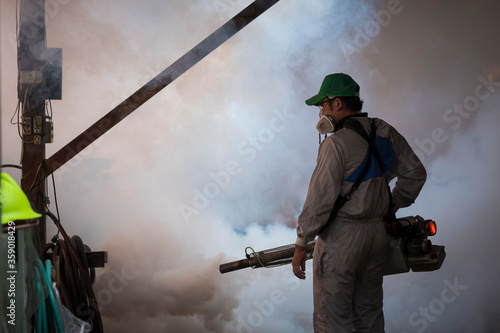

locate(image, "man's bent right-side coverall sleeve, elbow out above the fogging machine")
[[391, 128, 427, 209]]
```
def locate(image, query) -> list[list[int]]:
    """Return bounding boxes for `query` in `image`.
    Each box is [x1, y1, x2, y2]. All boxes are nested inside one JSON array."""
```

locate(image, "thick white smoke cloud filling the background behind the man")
[[0, 0, 500, 333]]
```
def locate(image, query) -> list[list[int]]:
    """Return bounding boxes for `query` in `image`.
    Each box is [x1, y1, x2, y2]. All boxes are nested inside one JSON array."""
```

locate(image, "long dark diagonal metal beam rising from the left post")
[[23, 0, 279, 186]]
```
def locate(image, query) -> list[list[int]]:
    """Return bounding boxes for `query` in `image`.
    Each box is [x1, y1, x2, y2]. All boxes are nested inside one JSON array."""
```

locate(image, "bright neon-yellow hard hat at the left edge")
[[0, 172, 42, 224]]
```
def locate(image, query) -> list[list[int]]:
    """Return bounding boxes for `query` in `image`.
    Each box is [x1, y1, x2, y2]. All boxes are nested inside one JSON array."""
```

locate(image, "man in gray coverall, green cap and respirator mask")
[[292, 73, 426, 333]]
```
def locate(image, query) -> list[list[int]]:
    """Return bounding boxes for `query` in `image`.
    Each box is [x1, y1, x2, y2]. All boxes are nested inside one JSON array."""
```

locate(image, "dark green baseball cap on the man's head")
[[306, 73, 359, 105]]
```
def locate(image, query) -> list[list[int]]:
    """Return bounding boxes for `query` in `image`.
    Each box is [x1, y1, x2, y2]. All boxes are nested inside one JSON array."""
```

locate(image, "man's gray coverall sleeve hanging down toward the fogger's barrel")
[[296, 140, 344, 246]]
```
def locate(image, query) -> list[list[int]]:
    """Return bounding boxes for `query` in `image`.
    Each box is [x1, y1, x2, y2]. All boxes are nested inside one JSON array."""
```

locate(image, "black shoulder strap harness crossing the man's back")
[[318, 118, 392, 233]]
